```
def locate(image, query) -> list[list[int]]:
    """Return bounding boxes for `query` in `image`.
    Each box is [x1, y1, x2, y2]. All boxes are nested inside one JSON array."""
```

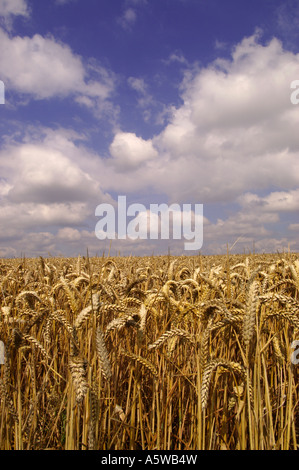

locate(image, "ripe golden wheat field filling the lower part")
[[0, 253, 299, 450]]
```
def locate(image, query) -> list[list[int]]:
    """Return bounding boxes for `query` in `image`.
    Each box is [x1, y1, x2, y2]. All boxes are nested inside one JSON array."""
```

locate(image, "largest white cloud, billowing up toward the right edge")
[[100, 30, 299, 204]]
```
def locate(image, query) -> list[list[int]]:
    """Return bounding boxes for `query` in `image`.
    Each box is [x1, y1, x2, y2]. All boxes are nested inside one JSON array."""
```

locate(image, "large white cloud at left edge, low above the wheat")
[[0, 129, 113, 255]]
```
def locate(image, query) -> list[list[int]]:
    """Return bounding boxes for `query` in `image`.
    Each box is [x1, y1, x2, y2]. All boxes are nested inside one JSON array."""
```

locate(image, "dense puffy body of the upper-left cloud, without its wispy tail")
[[0, 31, 84, 99]]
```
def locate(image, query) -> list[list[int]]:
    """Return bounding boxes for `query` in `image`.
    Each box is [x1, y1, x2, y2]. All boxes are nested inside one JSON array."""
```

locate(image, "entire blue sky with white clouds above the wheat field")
[[0, 0, 299, 257]]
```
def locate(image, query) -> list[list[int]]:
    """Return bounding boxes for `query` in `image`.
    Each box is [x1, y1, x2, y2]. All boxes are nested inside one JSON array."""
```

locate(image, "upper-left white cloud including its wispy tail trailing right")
[[0, 29, 115, 116]]
